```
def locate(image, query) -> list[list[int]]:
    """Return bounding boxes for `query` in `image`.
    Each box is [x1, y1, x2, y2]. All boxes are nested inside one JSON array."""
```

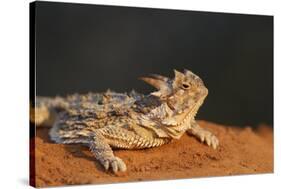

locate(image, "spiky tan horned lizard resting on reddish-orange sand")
[[31, 70, 219, 173]]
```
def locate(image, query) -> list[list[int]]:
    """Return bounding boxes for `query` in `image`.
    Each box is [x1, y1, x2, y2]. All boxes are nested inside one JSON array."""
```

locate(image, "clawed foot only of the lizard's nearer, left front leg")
[[101, 157, 127, 173]]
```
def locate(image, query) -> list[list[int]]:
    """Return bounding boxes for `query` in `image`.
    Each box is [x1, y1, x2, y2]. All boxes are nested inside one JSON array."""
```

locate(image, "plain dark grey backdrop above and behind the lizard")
[[32, 2, 273, 126]]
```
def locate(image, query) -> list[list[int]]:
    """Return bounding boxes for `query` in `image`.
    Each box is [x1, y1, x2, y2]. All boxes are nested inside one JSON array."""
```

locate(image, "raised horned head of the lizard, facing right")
[[141, 70, 208, 125]]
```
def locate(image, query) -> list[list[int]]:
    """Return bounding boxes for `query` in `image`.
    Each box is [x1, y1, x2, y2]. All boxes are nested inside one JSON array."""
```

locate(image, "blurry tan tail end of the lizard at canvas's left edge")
[[30, 96, 66, 127]]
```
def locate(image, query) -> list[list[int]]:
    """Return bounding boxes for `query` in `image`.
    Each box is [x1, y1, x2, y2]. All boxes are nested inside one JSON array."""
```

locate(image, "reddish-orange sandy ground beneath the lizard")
[[31, 121, 273, 187]]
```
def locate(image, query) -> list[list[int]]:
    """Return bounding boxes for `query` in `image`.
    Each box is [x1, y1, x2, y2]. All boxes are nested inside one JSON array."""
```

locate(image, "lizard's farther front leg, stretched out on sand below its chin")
[[187, 120, 219, 149]]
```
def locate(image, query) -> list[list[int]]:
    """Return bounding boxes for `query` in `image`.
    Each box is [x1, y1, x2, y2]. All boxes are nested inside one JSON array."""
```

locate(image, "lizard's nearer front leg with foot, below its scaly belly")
[[90, 130, 127, 173]]
